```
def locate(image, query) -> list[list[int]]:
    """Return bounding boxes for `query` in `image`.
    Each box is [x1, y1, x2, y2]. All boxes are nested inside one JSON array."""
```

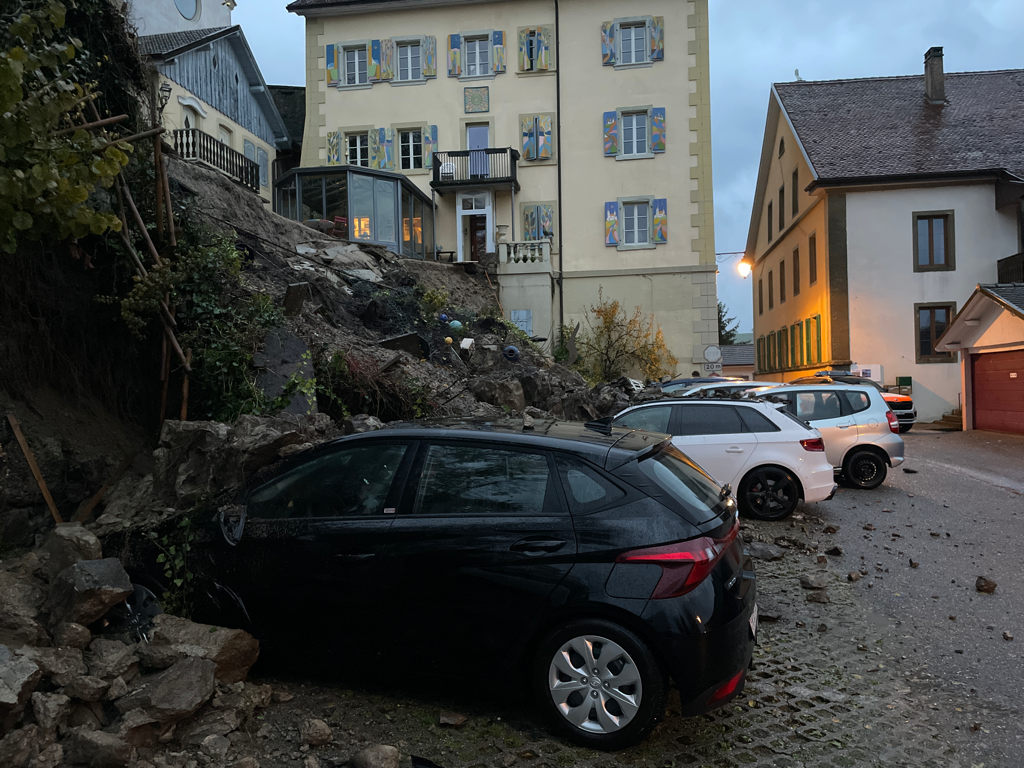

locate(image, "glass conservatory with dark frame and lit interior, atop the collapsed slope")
[[274, 166, 434, 259]]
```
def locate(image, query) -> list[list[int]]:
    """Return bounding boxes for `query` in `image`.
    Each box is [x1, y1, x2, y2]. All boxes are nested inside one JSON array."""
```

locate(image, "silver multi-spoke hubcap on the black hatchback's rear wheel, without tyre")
[[548, 635, 643, 733]]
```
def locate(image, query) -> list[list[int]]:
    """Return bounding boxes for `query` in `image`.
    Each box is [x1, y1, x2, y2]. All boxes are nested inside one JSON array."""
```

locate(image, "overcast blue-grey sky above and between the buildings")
[[234, 0, 1024, 332]]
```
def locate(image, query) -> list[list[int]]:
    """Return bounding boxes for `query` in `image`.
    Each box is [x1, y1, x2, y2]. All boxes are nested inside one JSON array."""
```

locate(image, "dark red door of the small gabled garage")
[[972, 349, 1024, 434]]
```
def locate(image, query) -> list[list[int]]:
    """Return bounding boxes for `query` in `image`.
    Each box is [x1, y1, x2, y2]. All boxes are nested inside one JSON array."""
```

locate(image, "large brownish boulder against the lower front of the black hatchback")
[[147, 613, 259, 683]]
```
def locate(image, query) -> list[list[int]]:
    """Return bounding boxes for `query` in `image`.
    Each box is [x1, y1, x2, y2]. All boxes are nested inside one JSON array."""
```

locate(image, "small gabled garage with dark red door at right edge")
[[935, 283, 1024, 434]]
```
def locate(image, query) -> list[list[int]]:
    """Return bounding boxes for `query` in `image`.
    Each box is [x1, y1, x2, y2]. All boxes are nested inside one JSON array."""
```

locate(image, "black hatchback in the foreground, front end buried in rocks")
[[116, 422, 757, 750]]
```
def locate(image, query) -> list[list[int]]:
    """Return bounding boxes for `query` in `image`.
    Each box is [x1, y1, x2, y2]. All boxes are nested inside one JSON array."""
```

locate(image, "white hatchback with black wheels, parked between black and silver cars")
[[611, 398, 837, 520]]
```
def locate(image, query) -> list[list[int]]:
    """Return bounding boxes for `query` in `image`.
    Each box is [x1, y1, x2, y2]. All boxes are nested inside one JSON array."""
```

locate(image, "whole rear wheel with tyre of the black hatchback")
[[532, 620, 668, 750]]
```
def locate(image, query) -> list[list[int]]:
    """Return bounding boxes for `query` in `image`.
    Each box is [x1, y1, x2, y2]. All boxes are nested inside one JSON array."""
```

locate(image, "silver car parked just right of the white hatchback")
[[757, 384, 903, 488]]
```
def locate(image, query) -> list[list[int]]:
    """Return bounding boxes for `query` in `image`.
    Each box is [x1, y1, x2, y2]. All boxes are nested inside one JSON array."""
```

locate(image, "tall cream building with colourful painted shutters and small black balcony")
[[288, 0, 718, 370]]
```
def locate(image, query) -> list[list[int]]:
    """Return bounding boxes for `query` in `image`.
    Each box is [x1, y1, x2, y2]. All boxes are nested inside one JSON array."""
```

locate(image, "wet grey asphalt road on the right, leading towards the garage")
[[819, 430, 1024, 760]]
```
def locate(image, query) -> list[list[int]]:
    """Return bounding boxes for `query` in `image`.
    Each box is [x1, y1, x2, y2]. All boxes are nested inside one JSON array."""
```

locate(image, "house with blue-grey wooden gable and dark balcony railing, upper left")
[[129, 0, 290, 206]]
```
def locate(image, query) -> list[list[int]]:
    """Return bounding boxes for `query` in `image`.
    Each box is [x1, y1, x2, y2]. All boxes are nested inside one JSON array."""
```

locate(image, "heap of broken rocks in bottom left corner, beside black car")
[[0, 523, 272, 768]]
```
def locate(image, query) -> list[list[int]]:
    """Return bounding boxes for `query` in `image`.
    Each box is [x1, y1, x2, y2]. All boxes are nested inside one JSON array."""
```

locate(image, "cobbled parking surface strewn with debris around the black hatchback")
[[243, 438, 1024, 768]]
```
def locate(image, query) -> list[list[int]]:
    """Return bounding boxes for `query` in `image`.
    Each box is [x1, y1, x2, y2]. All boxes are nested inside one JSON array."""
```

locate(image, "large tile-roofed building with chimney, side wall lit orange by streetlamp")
[[744, 48, 1024, 422]]
